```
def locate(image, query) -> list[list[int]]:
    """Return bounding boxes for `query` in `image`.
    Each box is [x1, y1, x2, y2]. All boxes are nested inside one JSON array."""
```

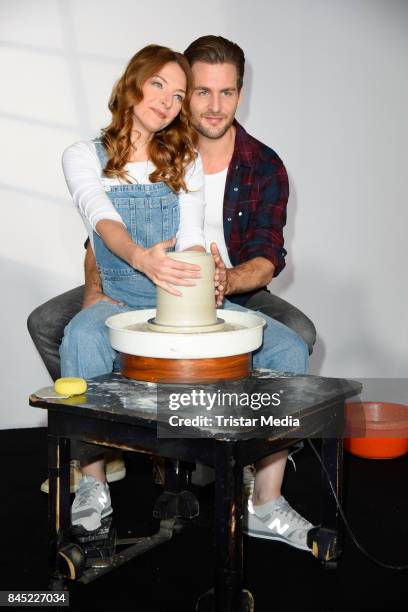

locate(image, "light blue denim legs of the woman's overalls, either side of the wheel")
[[60, 300, 309, 378]]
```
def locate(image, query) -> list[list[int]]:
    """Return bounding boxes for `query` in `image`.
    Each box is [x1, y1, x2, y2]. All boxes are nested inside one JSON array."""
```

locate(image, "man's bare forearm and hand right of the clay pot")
[[210, 242, 275, 305]]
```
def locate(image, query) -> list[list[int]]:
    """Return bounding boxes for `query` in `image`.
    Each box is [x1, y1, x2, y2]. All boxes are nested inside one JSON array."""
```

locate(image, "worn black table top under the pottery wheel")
[[30, 370, 361, 440]]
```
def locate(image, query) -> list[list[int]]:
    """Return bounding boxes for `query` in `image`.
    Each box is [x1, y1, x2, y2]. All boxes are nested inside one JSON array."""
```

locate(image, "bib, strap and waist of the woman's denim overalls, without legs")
[[93, 140, 180, 309]]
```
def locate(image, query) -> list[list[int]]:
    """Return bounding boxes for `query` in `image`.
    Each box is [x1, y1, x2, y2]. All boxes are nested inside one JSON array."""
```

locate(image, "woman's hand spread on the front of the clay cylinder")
[[133, 238, 200, 295]]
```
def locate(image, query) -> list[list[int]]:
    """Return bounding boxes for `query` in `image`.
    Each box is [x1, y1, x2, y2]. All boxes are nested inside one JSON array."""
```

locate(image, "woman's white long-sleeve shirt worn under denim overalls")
[[62, 141, 205, 251]]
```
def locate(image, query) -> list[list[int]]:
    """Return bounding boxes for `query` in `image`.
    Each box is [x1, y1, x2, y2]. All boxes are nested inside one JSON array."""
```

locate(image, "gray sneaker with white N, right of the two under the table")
[[243, 495, 313, 552]]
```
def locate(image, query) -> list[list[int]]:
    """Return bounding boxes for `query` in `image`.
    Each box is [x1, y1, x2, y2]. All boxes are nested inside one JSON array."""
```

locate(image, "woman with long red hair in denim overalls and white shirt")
[[60, 45, 205, 531]]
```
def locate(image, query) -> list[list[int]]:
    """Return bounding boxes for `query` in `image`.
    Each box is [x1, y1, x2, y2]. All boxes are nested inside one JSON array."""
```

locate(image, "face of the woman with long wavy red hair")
[[133, 62, 187, 136]]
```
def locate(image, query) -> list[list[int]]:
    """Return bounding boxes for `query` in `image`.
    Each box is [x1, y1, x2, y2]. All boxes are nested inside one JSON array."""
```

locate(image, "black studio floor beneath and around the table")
[[0, 428, 408, 612]]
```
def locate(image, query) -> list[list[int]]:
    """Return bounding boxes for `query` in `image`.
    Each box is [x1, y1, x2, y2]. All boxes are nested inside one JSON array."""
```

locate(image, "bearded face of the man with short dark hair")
[[190, 62, 240, 140]]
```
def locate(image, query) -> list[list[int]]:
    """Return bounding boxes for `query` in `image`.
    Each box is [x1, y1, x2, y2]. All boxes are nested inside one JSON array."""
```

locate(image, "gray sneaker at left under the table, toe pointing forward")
[[71, 476, 112, 531]]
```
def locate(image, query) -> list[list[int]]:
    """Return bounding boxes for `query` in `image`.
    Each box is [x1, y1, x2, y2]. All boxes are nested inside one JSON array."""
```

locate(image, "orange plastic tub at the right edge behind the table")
[[344, 402, 408, 459]]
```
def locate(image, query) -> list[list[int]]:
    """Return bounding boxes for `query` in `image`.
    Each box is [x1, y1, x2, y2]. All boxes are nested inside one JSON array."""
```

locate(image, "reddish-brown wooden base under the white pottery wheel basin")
[[121, 353, 251, 383]]
